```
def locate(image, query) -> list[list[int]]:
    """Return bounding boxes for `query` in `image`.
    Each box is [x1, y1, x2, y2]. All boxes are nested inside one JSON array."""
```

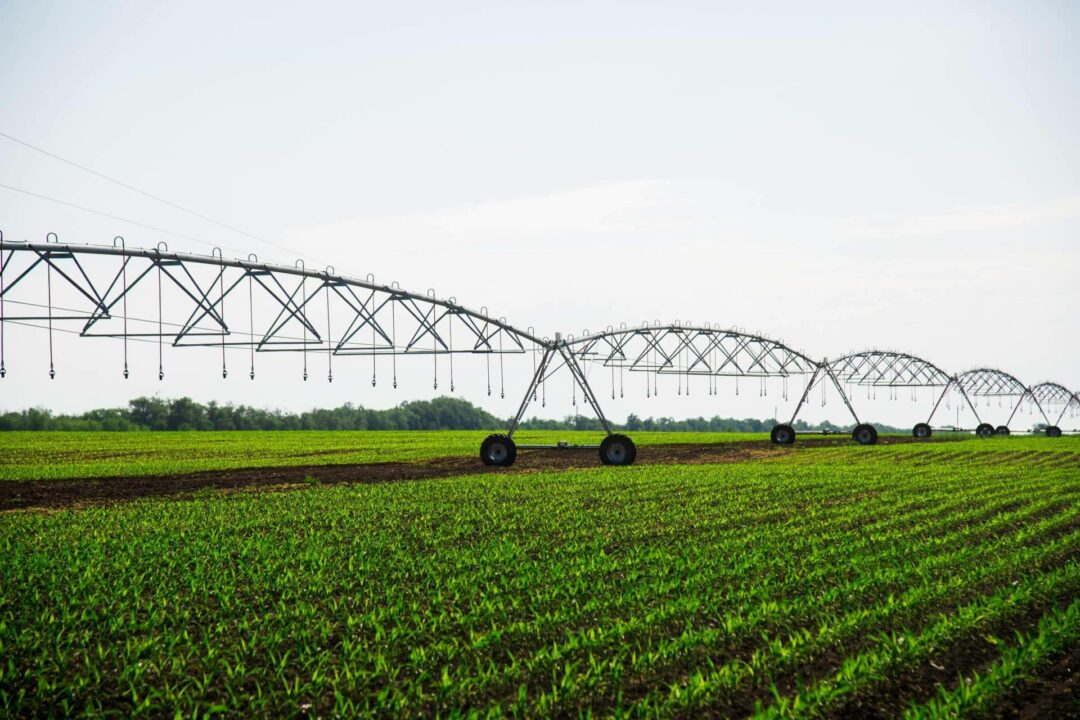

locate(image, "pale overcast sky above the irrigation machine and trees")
[[0, 0, 1080, 420]]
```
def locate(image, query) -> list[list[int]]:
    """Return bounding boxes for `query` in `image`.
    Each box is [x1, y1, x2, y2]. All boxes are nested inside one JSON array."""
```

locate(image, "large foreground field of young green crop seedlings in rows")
[[0, 433, 1080, 718]]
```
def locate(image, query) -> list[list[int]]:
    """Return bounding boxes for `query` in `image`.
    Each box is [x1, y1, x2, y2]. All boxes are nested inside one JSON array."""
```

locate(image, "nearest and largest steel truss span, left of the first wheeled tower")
[[0, 237, 543, 385]]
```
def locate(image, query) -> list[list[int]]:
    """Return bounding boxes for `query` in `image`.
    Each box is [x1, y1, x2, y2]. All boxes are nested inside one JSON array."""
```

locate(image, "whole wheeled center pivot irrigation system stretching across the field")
[[0, 233, 1080, 466]]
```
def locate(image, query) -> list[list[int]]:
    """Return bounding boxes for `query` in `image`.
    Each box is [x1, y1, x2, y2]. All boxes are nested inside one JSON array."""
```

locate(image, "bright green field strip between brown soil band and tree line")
[[0, 431, 768, 480]]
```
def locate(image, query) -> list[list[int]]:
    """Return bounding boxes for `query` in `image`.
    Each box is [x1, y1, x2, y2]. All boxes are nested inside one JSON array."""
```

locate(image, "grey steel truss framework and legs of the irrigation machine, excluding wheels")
[[0, 239, 1080, 435]]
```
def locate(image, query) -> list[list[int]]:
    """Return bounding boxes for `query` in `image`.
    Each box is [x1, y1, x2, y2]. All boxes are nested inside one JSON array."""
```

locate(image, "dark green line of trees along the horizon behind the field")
[[0, 397, 893, 433]]
